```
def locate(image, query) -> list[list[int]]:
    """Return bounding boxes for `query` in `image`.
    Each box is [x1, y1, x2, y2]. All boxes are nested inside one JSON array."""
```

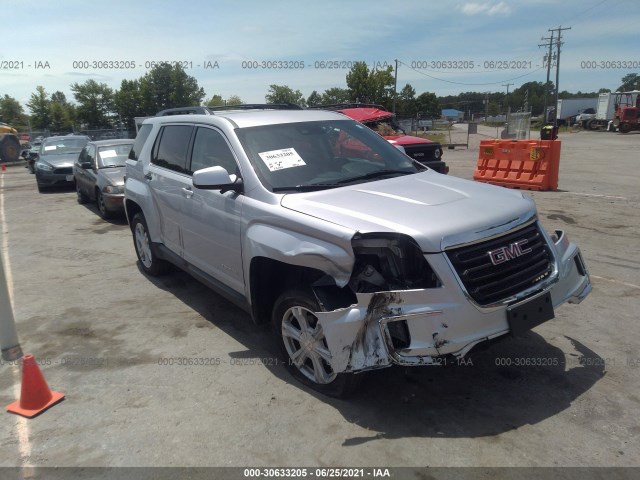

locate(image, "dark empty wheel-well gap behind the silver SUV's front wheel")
[[249, 257, 325, 324]]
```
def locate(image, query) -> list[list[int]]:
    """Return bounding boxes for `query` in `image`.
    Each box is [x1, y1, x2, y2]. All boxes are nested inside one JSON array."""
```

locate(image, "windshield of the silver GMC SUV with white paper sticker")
[[237, 120, 425, 191]]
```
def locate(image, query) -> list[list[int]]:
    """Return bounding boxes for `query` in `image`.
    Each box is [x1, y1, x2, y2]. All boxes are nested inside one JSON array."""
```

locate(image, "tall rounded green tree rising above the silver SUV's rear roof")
[[140, 63, 205, 115]]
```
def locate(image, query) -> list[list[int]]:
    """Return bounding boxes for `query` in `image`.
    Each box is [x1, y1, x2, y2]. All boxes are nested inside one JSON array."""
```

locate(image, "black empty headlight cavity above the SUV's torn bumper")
[[349, 233, 441, 293]]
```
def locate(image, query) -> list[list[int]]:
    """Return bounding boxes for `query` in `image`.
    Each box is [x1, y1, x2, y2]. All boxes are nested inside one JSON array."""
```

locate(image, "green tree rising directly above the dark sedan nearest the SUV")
[[71, 80, 114, 129]]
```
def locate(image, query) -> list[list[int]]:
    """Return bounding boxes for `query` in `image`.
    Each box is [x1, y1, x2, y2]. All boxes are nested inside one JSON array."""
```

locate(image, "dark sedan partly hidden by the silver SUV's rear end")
[[73, 140, 133, 218]]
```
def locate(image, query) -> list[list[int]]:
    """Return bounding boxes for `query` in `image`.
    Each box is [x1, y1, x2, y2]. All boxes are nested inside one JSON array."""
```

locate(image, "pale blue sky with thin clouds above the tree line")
[[0, 0, 640, 113]]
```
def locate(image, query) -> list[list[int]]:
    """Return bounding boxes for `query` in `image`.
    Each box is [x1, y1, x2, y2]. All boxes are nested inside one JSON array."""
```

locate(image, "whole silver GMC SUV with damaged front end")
[[125, 106, 591, 396]]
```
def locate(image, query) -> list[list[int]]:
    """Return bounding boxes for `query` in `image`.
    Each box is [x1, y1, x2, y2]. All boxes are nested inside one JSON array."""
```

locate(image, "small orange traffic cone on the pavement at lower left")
[[7, 355, 64, 418]]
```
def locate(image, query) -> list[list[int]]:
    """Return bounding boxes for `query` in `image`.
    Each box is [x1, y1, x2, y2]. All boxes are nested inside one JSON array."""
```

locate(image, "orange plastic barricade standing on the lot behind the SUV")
[[473, 140, 561, 190]]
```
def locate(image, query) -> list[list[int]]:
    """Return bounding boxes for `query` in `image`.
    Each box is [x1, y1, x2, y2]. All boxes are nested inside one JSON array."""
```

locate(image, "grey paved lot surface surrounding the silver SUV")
[[0, 125, 640, 478]]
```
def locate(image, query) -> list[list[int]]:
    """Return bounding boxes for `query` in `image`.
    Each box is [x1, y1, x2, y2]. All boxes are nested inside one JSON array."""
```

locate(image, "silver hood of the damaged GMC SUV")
[[281, 170, 536, 253]]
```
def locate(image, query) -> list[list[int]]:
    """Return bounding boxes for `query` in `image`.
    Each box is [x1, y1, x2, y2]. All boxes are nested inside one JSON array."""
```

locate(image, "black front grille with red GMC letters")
[[446, 223, 553, 305]]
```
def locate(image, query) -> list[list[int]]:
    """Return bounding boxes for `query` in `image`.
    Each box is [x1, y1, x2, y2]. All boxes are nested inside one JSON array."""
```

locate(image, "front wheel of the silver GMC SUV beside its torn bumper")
[[272, 290, 362, 398]]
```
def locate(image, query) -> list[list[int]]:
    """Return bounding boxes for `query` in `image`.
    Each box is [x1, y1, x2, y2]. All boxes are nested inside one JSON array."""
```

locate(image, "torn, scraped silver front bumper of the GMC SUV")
[[316, 231, 591, 373]]
